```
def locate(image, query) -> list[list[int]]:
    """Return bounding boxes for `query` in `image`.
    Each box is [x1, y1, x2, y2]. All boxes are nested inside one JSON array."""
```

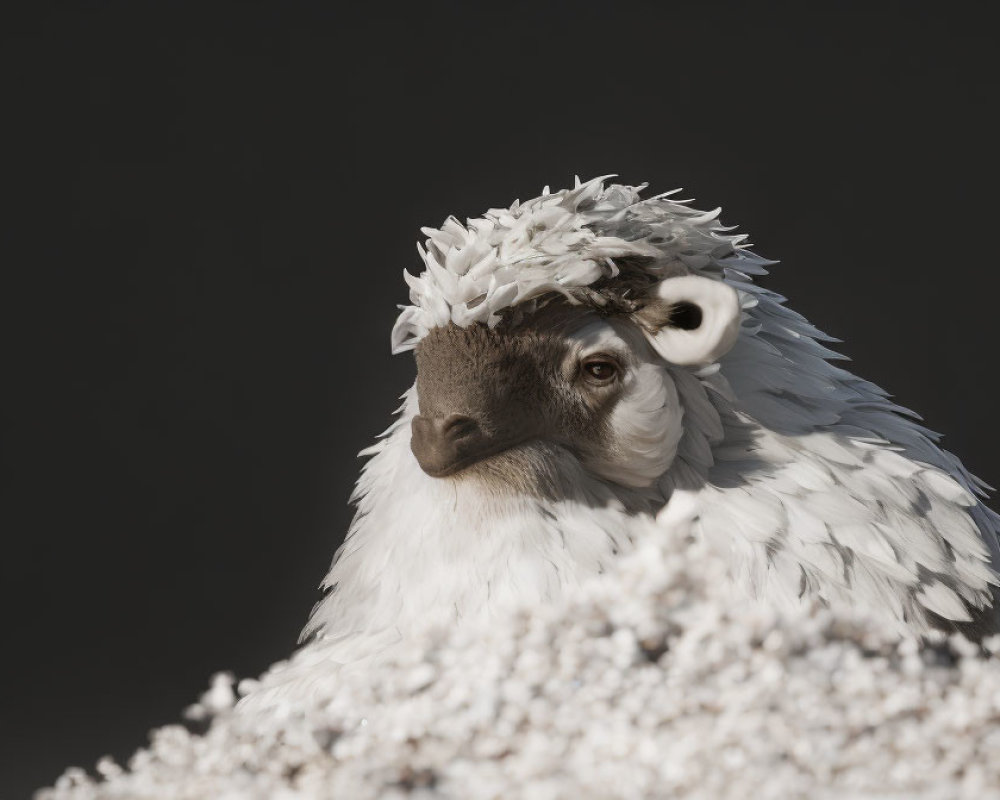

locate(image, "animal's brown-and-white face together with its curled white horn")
[[411, 275, 740, 487]]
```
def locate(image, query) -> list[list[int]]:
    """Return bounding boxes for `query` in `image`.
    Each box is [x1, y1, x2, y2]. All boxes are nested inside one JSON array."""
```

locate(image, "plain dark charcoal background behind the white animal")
[[0, 0, 1000, 798]]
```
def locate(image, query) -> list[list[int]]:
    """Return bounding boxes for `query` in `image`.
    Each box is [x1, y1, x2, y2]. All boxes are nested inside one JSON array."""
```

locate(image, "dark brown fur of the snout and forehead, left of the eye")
[[411, 308, 619, 477]]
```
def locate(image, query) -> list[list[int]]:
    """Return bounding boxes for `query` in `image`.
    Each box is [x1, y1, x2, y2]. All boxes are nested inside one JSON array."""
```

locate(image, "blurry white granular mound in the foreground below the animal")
[[38, 532, 1000, 800]]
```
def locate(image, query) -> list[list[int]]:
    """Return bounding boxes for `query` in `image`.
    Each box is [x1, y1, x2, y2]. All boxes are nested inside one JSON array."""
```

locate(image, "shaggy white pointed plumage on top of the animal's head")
[[392, 178, 746, 353]]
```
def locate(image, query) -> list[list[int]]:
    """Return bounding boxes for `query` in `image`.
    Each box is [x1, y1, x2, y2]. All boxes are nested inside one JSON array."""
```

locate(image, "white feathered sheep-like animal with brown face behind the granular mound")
[[286, 178, 1000, 680]]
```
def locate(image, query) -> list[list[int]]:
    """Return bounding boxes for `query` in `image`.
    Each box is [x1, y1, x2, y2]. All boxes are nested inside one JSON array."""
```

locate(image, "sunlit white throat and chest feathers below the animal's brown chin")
[[303, 390, 663, 639]]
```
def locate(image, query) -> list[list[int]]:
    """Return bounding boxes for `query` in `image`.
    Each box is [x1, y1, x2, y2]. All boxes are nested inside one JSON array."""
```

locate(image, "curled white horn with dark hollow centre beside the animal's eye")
[[636, 275, 740, 365]]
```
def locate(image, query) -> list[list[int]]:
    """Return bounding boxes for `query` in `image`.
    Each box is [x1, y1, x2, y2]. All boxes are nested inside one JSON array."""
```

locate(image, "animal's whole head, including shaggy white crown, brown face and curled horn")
[[393, 180, 742, 500]]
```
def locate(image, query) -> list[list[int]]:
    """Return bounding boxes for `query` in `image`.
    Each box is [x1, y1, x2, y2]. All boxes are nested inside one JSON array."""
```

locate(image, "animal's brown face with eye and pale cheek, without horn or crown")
[[411, 307, 680, 486]]
